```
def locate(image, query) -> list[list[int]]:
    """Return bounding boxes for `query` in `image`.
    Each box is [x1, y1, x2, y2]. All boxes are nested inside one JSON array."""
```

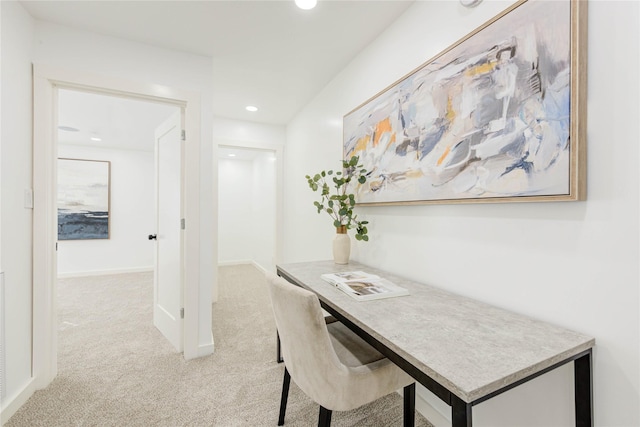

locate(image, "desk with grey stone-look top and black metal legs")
[[277, 261, 595, 427]]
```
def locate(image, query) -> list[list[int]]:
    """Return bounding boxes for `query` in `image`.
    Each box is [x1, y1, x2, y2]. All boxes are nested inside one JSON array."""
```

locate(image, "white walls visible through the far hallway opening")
[[218, 150, 277, 271]]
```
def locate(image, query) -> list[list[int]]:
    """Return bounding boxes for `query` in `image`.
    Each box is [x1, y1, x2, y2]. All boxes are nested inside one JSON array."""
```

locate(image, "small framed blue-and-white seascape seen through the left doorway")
[[58, 159, 111, 240]]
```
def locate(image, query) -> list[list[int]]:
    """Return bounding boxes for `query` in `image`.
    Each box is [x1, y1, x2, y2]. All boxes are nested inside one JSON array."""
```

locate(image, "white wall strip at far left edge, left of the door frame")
[[0, 1, 34, 414]]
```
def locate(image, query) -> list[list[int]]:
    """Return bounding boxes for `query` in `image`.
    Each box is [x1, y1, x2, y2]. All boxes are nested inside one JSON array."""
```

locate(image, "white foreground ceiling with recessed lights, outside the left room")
[[21, 0, 412, 124]]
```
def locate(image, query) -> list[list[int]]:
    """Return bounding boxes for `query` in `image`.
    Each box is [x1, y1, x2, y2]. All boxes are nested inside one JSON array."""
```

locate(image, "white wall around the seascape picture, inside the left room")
[[58, 145, 155, 277]]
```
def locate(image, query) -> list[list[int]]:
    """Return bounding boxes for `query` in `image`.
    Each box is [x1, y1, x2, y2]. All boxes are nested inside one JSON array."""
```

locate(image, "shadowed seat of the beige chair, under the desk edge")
[[327, 322, 384, 368]]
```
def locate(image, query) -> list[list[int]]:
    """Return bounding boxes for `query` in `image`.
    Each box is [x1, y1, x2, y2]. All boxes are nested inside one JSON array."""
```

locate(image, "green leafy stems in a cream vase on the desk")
[[306, 156, 369, 264]]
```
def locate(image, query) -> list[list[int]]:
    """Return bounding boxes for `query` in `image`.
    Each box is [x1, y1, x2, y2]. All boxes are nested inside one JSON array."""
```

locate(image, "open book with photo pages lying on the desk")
[[320, 271, 409, 301]]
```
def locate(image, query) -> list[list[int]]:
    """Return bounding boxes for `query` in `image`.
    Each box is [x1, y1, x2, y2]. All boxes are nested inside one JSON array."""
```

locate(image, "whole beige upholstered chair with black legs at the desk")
[[267, 273, 415, 426]]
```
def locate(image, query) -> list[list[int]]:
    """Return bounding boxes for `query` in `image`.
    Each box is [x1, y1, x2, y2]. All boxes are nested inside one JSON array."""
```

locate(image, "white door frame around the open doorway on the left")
[[32, 64, 200, 389]]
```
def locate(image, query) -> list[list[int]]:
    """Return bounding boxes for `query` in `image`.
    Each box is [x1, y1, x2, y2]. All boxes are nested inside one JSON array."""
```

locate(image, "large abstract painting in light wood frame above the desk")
[[343, 0, 587, 204]]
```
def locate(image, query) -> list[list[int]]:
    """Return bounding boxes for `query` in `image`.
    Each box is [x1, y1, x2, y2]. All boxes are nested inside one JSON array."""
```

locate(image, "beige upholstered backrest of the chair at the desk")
[[267, 273, 348, 405]]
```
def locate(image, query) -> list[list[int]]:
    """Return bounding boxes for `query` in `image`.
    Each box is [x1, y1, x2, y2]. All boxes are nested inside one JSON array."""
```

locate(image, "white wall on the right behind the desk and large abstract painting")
[[284, 1, 640, 426]]
